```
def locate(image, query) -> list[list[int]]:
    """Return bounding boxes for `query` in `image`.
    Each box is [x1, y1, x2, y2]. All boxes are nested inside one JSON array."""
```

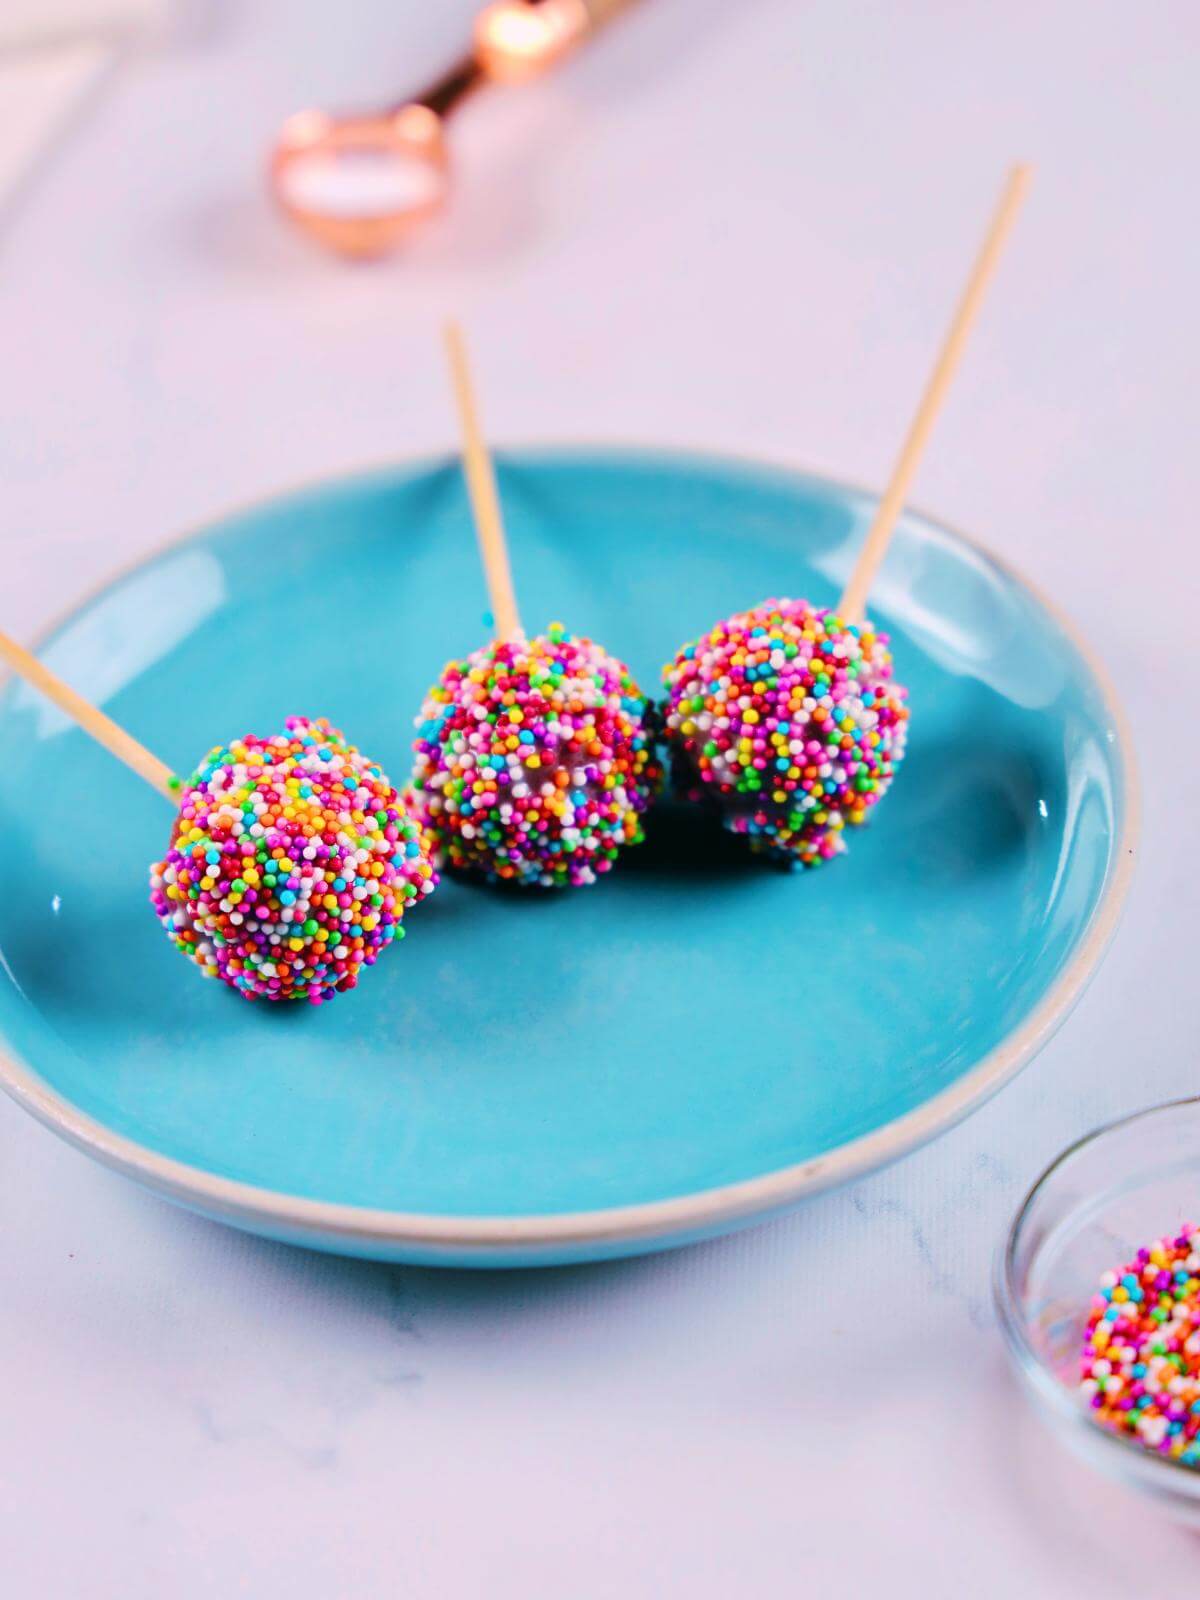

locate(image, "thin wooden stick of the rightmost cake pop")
[[838, 165, 1032, 622]]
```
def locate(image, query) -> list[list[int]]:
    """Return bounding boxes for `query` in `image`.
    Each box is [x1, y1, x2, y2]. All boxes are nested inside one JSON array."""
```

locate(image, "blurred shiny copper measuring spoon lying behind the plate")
[[270, 0, 630, 256]]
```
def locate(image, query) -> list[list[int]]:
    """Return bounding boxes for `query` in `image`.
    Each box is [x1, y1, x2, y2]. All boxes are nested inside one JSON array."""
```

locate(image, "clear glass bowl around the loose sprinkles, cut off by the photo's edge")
[[995, 1099, 1200, 1528]]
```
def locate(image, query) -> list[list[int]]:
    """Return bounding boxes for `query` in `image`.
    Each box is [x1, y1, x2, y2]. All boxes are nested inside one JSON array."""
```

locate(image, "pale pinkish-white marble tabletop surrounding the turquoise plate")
[[0, 0, 1200, 1600]]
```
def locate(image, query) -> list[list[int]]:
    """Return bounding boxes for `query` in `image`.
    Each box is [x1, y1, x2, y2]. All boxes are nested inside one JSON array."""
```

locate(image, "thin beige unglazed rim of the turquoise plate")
[[0, 440, 1141, 1258]]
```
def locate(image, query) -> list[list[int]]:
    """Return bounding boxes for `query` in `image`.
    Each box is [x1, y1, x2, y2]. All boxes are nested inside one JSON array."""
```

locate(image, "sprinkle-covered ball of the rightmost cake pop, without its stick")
[[662, 600, 909, 867]]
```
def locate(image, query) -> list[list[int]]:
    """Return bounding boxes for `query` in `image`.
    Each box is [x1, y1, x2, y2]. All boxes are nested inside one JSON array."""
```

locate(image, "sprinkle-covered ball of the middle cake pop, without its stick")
[[406, 622, 662, 888]]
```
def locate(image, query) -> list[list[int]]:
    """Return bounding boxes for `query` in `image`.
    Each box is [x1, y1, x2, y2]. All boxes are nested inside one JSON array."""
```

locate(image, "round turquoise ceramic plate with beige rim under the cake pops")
[[0, 450, 1133, 1266]]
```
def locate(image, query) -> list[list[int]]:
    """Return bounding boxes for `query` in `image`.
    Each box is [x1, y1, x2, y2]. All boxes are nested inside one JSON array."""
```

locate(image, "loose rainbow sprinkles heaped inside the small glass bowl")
[[1080, 1222, 1200, 1467]]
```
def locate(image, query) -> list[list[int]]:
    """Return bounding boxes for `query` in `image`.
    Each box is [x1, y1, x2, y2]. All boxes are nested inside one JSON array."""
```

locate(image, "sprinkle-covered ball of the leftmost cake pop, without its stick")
[[150, 717, 437, 1005]]
